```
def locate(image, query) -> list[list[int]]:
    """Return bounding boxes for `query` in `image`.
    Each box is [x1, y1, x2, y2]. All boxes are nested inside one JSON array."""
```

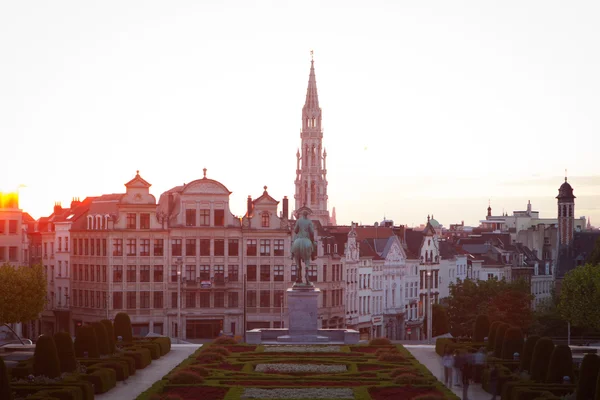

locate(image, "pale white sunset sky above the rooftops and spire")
[[0, 0, 600, 226]]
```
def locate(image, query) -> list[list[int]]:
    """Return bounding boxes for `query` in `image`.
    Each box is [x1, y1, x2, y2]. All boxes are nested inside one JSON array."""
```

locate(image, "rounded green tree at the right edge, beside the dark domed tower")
[[558, 264, 600, 329]]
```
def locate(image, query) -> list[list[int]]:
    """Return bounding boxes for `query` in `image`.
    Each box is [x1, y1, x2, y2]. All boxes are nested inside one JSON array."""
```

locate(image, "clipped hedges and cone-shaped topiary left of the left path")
[[0, 313, 171, 400]]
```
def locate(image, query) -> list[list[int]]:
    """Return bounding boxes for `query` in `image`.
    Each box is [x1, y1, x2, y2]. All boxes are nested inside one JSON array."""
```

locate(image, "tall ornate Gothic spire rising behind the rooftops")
[[294, 54, 331, 225]]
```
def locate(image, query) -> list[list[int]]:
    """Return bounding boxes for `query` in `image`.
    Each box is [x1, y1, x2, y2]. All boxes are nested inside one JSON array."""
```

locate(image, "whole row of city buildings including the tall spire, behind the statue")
[[0, 58, 589, 340]]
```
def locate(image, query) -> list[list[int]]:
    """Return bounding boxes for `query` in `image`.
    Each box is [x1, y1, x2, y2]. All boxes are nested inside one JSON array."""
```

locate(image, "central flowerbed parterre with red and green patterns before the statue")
[[138, 337, 458, 400]]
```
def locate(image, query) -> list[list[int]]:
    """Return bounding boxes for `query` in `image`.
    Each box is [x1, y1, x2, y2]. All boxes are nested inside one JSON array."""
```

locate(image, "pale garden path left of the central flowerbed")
[[94, 344, 202, 400]]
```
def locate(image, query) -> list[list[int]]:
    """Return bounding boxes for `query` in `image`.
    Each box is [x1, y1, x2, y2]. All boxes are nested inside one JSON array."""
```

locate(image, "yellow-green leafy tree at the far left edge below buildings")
[[0, 264, 47, 324]]
